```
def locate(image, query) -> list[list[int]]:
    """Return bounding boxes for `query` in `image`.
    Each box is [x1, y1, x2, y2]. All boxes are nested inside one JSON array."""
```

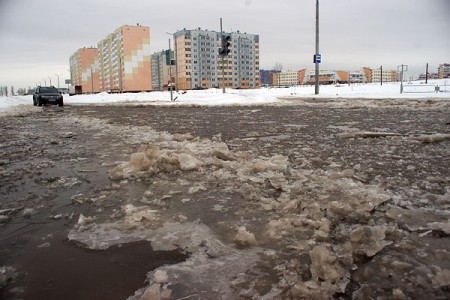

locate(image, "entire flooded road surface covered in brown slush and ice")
[[0, 98, 450, 299]]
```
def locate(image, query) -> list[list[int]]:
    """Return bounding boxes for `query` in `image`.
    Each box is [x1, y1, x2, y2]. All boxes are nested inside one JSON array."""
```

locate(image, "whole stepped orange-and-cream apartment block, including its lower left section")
[[70, 25, 152, 93]]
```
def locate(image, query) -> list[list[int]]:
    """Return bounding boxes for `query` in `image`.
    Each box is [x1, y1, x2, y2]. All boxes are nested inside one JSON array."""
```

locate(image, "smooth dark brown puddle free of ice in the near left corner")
[[2, 241, 187, 300]]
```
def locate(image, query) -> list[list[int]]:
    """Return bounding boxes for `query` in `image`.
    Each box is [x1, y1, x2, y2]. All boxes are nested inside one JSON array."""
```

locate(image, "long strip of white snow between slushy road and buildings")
[[0, 79, 450, 115]]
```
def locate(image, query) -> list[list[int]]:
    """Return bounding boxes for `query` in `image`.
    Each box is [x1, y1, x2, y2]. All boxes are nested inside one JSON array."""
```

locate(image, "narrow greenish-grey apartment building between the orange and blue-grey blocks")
[[151, 50, 176, 91]]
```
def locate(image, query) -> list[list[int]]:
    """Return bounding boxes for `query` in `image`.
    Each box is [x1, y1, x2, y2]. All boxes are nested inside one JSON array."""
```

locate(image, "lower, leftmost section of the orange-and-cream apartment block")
[[69, 48, 100, 93]]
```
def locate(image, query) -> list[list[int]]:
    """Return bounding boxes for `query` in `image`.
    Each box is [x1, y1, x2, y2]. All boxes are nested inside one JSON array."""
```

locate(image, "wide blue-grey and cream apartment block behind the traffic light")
[[174, 28, 260, 89]]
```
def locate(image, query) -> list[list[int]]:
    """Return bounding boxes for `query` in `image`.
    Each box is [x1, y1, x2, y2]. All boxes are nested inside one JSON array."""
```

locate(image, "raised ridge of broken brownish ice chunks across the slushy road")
[[96, 128, 402, 298]]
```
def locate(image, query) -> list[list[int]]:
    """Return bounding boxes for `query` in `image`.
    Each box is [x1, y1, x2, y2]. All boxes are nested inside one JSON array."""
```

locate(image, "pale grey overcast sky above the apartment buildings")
[[0, 0, 450, 89]]
